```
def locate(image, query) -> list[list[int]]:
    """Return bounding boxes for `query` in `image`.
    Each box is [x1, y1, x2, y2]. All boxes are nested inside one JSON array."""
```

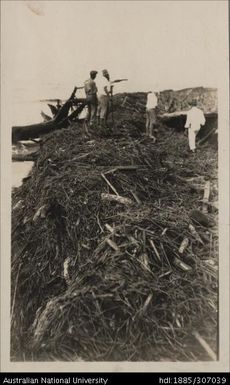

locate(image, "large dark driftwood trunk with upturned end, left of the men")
[[12, 87, 87, 143]]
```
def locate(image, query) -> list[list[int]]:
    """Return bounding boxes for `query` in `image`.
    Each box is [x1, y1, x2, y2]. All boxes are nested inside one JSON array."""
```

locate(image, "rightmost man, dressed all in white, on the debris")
[[185, 100, 205, 152]]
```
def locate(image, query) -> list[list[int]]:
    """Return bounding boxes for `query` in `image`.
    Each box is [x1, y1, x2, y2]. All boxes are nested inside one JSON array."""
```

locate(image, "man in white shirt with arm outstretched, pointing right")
[[97, 70, 113, 128]]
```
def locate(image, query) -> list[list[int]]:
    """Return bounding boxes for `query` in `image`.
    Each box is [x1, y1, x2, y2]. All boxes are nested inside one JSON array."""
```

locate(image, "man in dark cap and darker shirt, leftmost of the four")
[[84, 71, 98, 126]]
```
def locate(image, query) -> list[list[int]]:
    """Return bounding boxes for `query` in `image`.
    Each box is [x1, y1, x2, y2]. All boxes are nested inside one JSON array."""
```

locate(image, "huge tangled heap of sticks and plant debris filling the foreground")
[[11, 113, 218, 361]]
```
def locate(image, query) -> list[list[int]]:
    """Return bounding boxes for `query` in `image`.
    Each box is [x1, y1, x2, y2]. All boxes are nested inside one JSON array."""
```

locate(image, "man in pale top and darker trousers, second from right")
[[146, 91, 158, 142]]
